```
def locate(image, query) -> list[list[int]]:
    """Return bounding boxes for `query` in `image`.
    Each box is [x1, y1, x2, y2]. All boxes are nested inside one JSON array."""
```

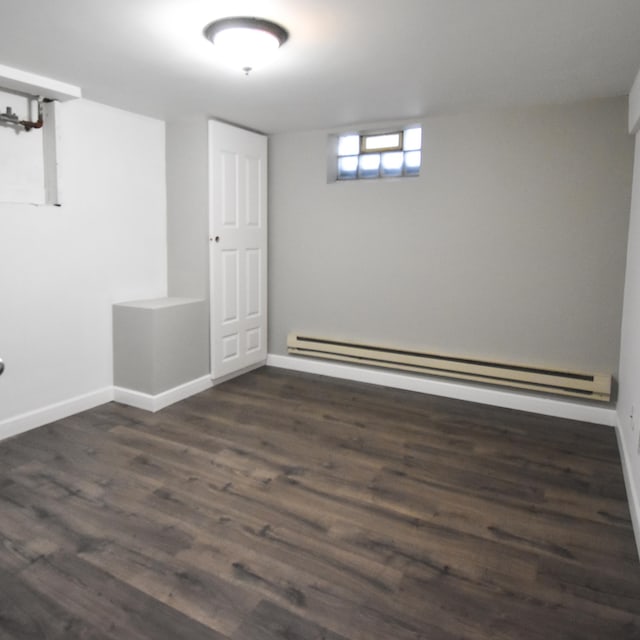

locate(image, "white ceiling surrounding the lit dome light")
[[0, 0, 640, 132]]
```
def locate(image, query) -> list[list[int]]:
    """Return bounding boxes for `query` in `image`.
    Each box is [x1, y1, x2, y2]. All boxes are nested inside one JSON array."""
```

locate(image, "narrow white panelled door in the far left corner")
[[209, 121, 267, 380]]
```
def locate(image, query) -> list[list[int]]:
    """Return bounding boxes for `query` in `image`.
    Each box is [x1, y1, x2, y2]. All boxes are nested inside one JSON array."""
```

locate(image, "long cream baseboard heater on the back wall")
[[287, 333, 611, 402]]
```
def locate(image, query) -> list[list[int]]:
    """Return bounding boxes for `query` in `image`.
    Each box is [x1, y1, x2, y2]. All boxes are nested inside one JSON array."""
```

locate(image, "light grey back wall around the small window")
[[269, 98, 633, 373]]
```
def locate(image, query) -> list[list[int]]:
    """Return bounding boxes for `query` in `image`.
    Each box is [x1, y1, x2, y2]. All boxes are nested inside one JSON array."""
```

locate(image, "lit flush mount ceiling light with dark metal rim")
[[204, 17, 289, 75]]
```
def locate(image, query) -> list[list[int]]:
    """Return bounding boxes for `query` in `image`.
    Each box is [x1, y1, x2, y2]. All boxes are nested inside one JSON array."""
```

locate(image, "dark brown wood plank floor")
[[0, 368, 640, 640]]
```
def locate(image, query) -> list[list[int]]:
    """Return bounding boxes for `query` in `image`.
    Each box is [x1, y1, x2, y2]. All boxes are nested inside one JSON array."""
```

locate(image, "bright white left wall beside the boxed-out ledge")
[[0, 100, 166, 422]]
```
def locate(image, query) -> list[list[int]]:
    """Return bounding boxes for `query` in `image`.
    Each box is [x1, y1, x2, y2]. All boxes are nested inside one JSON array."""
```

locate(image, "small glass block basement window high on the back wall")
[[336, 126, 422, 180]]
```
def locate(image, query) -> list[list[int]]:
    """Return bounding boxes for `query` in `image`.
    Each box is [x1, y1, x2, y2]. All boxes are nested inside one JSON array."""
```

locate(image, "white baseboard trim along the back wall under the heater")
[[267, 354, 616, 427]]
